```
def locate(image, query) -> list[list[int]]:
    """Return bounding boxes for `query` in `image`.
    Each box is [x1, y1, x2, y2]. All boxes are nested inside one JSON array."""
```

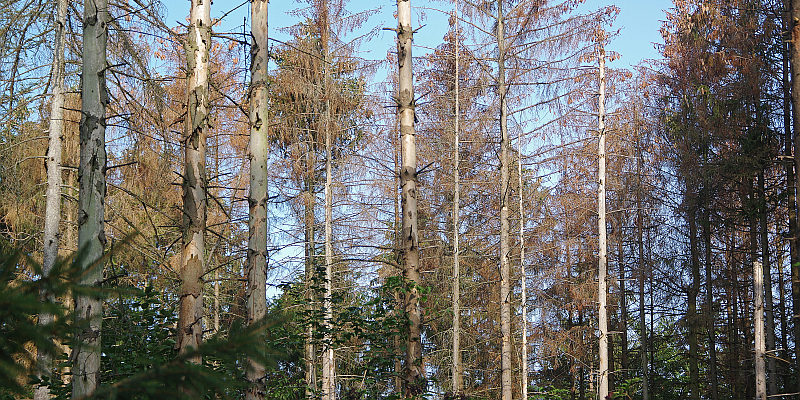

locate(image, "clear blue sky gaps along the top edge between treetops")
[[164, 0, 672, 68]]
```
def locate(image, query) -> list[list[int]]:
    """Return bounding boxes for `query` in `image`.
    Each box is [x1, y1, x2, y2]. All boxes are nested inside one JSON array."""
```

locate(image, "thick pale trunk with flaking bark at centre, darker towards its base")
[[397, 0, 428, 398]]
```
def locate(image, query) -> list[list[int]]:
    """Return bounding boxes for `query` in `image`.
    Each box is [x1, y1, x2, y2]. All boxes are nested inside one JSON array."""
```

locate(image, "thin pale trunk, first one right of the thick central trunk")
[[452, 0, 464, 397]]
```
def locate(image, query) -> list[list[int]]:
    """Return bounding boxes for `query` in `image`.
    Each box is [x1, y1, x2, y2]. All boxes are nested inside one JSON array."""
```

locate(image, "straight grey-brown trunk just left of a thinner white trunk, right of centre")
[[495, 0, 513, 400]]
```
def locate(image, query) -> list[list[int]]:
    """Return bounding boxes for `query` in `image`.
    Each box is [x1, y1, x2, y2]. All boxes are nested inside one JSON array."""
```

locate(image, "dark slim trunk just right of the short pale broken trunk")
[[758, 171, 778, 395]]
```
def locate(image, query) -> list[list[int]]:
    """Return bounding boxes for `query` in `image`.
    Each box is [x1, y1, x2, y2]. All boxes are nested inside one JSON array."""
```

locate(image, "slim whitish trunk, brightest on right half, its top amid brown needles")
[[597, 43, 609, 399]]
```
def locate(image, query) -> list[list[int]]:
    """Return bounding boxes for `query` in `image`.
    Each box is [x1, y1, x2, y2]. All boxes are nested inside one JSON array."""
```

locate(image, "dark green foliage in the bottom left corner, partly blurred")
[[0, 247, 282, 400]]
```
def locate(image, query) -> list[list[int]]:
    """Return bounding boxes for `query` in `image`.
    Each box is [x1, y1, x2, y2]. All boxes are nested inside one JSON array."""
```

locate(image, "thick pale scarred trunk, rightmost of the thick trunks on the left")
[[245, 0, 269, 400]]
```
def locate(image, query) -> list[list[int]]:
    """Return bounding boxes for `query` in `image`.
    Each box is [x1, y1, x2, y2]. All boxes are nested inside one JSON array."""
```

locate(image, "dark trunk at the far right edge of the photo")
[[789, 0, 800, 399]]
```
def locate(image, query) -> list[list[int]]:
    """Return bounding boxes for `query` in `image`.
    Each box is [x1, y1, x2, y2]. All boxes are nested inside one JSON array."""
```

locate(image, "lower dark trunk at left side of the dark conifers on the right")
[[686, 205, 700, 400]]
